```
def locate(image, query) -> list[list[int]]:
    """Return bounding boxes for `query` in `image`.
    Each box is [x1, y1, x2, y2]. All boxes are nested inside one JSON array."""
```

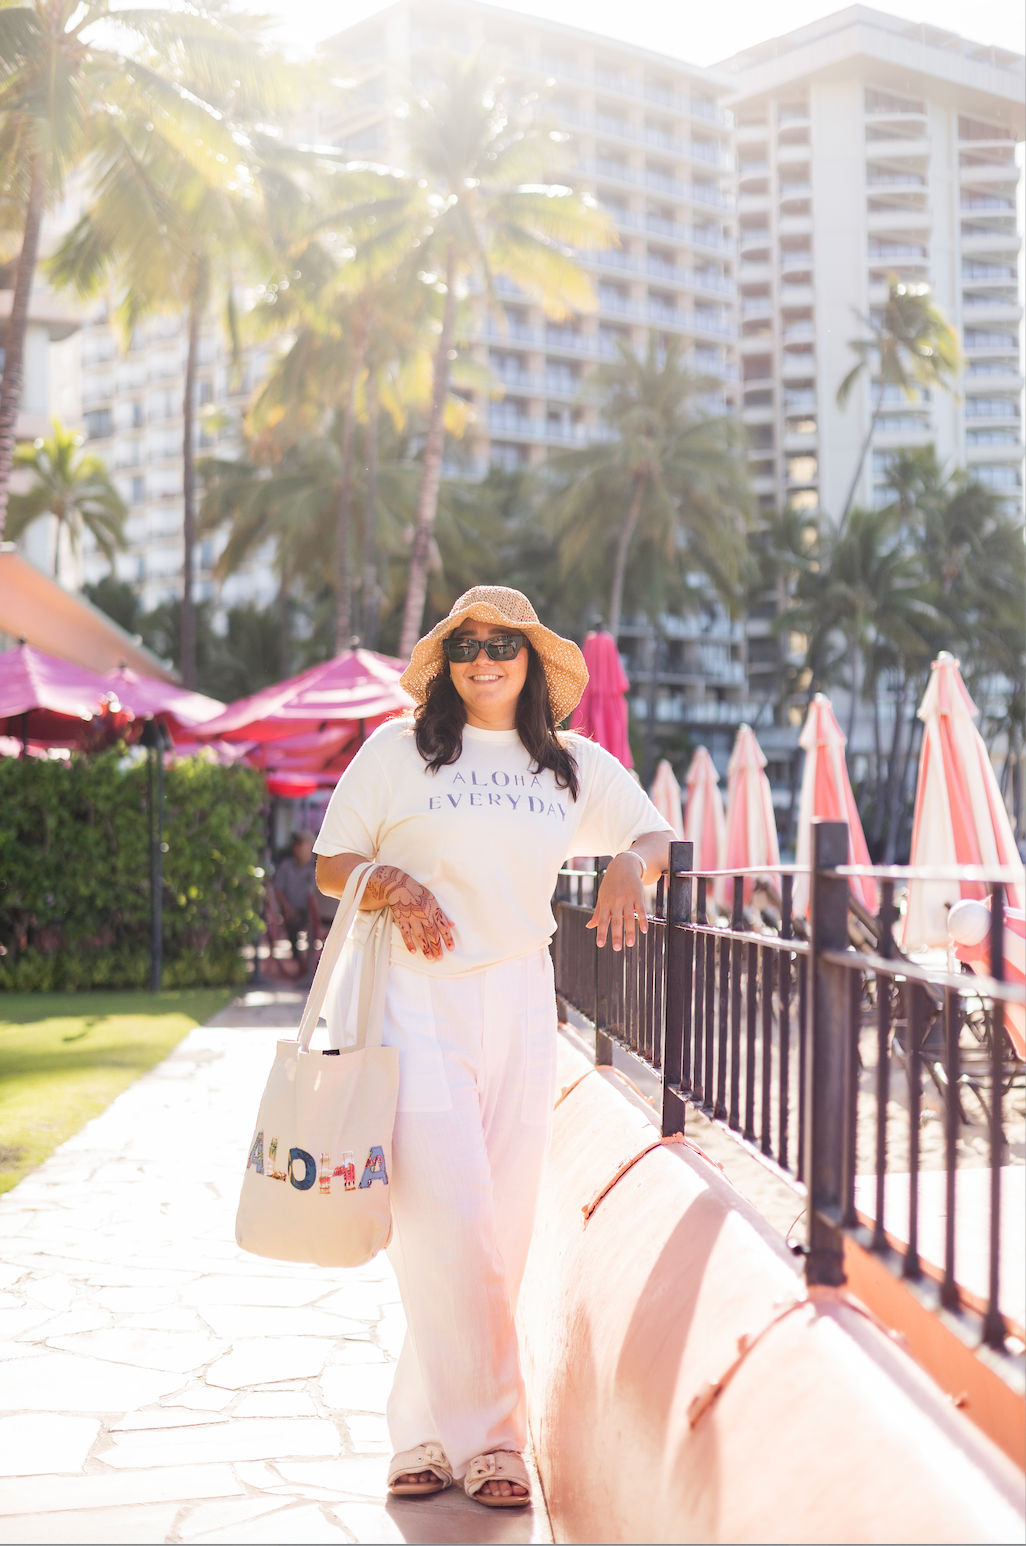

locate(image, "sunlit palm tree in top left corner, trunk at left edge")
[[0, 0, 295, 536]]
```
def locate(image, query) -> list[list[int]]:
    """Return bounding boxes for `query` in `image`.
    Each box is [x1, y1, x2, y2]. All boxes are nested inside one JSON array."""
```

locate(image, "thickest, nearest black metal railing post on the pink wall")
[[802, 821, 853, 1285]]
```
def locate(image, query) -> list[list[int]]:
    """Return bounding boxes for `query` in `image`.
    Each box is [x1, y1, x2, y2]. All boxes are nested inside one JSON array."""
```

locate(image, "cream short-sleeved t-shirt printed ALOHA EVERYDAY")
[[314, 719, 674, 977]]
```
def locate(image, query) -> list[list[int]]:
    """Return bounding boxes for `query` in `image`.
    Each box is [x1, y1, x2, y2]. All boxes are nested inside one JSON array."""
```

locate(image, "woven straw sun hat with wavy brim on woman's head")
[[400, 584, 587, 724]]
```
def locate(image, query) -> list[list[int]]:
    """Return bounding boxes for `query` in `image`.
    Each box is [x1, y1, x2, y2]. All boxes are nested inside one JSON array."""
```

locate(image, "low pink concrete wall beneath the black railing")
[[521, 1042, 1026, 1543]]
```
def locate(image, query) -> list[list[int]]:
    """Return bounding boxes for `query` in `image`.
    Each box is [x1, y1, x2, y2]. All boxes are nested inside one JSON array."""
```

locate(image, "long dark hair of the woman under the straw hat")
[[414, 638, 581, 799]]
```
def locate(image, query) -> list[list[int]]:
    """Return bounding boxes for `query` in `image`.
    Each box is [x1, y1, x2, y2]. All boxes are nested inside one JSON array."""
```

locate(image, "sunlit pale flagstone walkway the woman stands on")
[[0, 993, 552, 1546]]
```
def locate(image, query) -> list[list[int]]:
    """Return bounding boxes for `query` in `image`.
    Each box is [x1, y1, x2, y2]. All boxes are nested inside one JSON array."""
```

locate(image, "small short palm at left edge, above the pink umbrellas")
[[6, 419, 128, 580]]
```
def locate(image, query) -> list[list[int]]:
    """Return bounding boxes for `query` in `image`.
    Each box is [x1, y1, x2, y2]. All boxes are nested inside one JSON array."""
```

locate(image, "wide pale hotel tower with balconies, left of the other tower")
[[323, 0, 757, 751]]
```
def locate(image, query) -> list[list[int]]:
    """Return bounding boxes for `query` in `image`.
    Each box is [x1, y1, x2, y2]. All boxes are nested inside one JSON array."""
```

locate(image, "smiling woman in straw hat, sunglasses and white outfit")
[[315, 586, 672, 1507]]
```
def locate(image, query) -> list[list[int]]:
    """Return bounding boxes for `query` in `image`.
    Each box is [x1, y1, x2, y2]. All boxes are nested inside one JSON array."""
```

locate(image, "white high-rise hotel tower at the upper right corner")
[[720, 5, 1024, 518]]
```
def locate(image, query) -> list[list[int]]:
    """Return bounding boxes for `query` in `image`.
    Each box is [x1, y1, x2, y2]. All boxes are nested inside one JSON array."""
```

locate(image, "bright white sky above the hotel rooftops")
[[271, 0, 1026, 65]]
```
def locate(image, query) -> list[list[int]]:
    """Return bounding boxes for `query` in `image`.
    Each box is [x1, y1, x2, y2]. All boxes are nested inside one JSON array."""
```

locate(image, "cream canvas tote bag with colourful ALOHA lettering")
[[235, 863, 399, 1266]]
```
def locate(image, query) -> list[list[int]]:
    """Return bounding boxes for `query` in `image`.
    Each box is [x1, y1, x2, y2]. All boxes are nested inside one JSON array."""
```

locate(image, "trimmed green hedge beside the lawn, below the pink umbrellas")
[[0, 748, 264, 993]]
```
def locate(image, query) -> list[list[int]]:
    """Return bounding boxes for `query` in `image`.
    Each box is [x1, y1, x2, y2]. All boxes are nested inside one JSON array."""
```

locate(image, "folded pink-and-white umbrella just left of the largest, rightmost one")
[[794, 693, 876, 917]]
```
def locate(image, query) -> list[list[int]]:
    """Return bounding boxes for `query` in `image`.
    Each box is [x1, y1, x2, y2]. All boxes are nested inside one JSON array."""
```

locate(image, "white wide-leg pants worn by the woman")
[[329, 949, 556, 1478]]
